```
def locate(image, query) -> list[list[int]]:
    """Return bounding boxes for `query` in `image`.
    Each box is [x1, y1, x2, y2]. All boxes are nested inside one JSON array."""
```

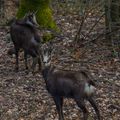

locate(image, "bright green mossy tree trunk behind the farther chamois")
[[17, 0, 57, 30]]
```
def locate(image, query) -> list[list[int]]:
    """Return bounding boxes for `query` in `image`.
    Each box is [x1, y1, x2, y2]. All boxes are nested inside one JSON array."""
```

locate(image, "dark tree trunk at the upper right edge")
[[105, 0, 120, 58]]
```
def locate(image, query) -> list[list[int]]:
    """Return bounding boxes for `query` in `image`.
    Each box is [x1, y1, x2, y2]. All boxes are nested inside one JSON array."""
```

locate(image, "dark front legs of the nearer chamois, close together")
[[53, 96, 64, 120]]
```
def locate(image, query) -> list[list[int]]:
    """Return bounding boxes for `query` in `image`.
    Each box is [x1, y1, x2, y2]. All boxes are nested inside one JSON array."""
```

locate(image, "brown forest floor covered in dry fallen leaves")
[[0, 7, 120, 120]]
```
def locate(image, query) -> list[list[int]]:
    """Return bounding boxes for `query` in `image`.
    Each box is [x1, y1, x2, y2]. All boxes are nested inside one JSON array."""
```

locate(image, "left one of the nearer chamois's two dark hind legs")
[[75, 98, 88, 120]]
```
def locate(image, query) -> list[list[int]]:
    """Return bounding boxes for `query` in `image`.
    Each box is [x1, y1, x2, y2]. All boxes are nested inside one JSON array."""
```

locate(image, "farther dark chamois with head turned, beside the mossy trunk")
[[10, 13, 41, 72]]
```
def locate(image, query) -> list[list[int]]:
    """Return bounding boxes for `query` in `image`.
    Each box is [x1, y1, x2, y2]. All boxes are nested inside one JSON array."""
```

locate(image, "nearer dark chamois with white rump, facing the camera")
[[42, 45, 100, 120]]
